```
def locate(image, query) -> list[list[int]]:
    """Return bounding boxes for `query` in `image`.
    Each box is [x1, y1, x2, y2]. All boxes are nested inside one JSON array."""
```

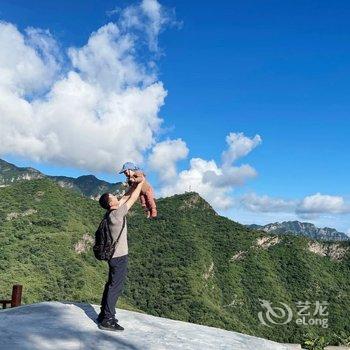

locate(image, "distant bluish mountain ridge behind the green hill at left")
[[0, 159, 121, 198]]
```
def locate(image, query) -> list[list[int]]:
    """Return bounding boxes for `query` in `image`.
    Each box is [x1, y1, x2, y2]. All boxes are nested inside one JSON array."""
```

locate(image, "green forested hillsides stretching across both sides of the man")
[[0, 179, 350, 343]]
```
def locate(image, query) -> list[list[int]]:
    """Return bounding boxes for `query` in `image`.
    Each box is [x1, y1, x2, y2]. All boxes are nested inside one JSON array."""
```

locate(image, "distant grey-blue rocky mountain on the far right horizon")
[[247, 221, 350, 241]]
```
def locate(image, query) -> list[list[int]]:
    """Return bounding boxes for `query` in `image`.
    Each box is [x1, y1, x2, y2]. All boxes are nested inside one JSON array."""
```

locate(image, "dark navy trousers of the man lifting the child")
[[103, 255, 128, 319]]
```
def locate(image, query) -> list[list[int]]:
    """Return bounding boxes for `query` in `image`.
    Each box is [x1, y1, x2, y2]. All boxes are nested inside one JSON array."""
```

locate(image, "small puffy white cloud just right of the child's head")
[[148, 139, 189, 183]]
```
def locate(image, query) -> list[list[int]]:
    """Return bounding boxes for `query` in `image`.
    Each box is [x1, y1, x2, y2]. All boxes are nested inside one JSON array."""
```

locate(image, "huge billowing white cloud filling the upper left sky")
[[0, 0, 167, 171]]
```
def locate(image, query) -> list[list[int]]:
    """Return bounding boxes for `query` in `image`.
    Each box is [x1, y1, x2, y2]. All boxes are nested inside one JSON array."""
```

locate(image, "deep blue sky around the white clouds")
[[0, 0, 350, 232]]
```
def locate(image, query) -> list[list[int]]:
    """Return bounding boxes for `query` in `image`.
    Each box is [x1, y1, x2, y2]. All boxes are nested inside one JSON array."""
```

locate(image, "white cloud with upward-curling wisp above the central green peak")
[[153, 133, 261, 209]]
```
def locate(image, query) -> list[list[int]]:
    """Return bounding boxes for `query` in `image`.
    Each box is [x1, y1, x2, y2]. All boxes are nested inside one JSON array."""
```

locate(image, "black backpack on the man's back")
[[92, 209, 125, 260]]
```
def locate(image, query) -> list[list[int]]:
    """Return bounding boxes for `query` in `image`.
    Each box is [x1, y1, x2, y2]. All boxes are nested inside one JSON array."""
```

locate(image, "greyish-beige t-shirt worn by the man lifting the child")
[[108, 203, 128, 258]]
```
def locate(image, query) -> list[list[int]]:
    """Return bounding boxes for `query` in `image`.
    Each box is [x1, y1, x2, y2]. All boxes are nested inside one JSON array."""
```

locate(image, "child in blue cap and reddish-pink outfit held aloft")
[[119, 162, 157, 219]]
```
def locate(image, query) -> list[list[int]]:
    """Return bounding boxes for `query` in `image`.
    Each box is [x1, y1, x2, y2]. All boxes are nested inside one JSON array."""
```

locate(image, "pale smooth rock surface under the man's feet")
[[0, 302, 288, 350]]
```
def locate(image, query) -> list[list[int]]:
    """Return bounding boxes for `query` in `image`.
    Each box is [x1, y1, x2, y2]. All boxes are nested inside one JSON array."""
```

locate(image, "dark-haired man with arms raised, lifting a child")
[[97, 179, 145, 331]]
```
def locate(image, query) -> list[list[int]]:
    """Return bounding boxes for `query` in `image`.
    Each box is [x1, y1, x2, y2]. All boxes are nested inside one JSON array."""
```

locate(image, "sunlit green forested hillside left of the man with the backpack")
[[0, 179, 105, 303]]
